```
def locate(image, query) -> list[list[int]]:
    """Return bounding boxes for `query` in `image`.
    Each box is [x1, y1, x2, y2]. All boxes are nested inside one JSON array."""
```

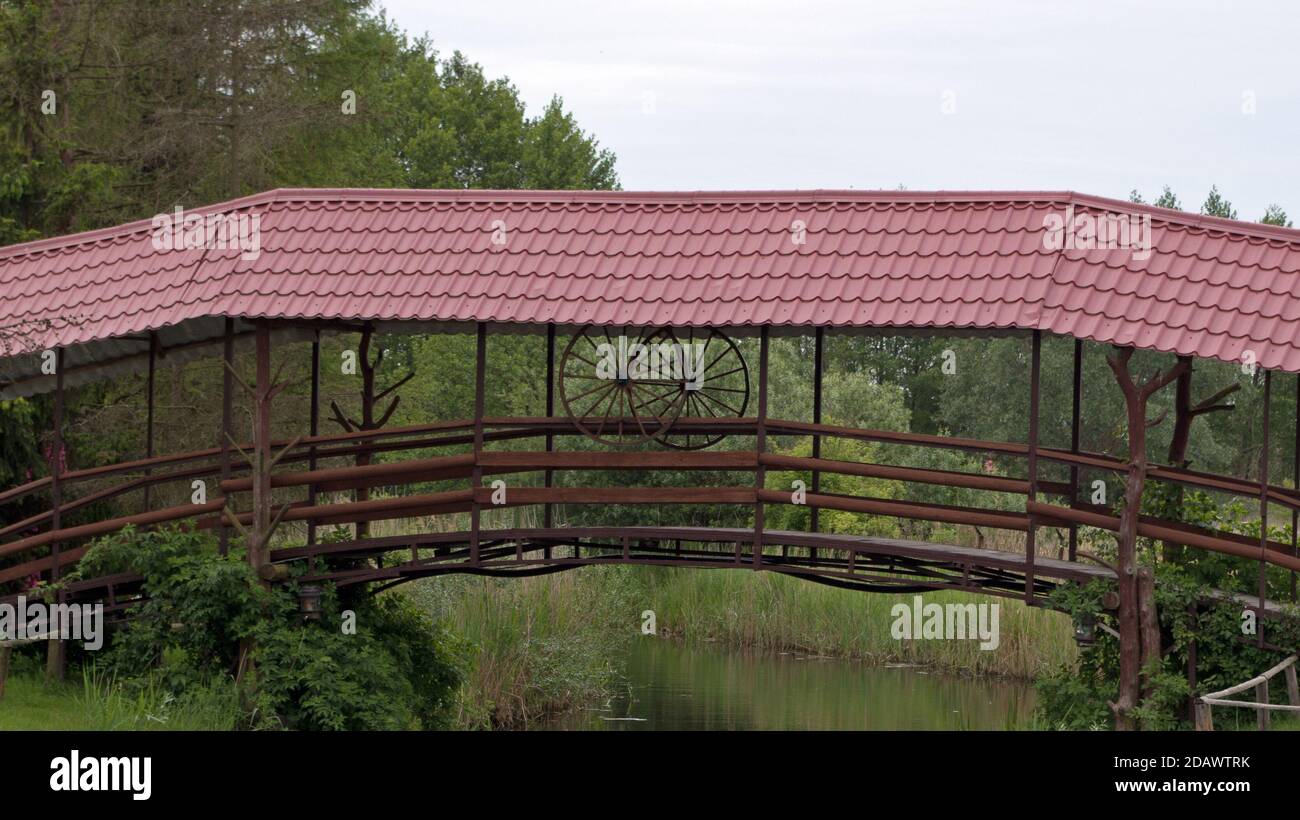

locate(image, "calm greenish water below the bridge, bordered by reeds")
[[547, 638, 1034, 730]]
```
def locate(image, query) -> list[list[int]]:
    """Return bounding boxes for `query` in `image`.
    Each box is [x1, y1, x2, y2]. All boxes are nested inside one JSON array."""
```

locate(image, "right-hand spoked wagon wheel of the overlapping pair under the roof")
[[655, 327, 749, 450]]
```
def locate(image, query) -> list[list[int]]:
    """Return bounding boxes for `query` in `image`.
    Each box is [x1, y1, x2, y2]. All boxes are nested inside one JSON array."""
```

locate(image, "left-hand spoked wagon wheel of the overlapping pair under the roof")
[[559, 325, 681, 447]]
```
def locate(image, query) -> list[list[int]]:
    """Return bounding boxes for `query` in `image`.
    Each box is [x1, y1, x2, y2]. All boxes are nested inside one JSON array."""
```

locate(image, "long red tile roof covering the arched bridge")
[[0, 190, 1300, 372]]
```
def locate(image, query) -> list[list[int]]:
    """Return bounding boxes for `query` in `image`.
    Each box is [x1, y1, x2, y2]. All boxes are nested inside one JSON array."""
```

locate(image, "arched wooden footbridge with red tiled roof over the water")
[[0, 191, 1300, 732]]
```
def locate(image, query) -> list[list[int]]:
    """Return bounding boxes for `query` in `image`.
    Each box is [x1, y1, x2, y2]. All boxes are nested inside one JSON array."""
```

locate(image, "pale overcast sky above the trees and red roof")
[[380, 0, 1300, 222]]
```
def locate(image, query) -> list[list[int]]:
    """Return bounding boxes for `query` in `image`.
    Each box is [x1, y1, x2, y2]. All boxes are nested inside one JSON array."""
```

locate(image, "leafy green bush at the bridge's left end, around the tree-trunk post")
[[73, 528, 463, 729]]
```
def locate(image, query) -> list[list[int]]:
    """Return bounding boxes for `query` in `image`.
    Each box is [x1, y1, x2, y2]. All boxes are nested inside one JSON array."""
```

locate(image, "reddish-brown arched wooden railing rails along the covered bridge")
[[0, 417, 1300, 602]]
